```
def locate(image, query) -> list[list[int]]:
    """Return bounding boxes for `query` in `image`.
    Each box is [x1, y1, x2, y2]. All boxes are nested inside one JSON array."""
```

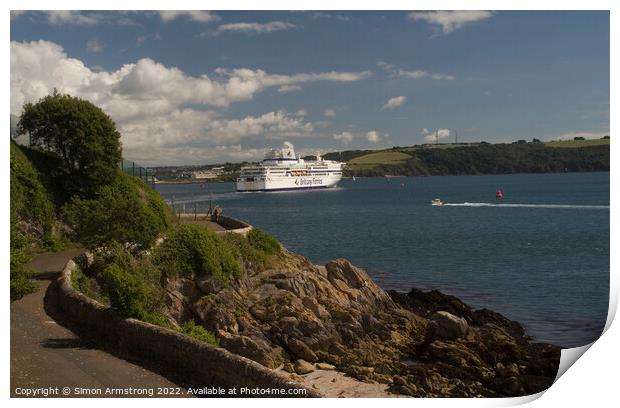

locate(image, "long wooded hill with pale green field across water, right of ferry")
[[323, 137, 609, 177]]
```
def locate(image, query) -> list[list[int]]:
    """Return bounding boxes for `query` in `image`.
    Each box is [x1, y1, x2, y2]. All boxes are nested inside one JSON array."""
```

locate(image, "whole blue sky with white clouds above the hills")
[[10, 11, 610, 166]]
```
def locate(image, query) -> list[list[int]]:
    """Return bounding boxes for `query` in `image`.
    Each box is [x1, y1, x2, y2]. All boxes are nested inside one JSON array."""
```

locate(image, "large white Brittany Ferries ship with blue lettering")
[[237, 142, 344, 191]]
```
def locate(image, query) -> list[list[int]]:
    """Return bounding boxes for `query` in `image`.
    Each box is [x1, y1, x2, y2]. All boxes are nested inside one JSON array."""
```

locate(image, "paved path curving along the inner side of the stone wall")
[[11, 250, 184, 396]]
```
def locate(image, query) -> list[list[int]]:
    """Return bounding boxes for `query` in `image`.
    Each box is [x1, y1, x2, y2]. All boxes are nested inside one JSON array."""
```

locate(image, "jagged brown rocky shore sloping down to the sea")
[[165, 251, 560, 397]]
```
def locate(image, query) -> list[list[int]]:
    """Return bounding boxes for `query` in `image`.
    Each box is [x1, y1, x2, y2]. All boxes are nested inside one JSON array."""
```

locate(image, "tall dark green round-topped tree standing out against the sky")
[[17, 90, 121, 195]]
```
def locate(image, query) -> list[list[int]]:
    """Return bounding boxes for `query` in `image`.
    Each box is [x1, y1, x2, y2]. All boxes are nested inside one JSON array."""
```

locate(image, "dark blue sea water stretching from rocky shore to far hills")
[[157, 173, 609, 347]]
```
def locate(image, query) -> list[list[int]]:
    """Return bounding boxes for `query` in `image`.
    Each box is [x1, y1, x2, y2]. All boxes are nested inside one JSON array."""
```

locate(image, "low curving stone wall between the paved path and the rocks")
[[45, 255, 321, 397]]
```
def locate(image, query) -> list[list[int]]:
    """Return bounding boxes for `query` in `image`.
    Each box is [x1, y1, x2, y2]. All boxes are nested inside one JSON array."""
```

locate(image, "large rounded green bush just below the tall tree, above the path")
[[62, 171, 171, 250]]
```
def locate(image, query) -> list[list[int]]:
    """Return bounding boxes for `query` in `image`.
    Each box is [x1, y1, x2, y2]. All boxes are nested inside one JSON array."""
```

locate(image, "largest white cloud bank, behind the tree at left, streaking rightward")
[[10, 41, 369, 165]]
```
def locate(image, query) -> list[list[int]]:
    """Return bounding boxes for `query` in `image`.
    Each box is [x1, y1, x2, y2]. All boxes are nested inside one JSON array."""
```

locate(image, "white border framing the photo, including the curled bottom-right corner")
[[0, 0, 620, 407]]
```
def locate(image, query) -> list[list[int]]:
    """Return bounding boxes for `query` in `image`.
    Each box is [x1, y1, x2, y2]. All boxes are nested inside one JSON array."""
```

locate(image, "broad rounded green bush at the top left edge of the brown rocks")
[[153, 225, 241, 285]]
